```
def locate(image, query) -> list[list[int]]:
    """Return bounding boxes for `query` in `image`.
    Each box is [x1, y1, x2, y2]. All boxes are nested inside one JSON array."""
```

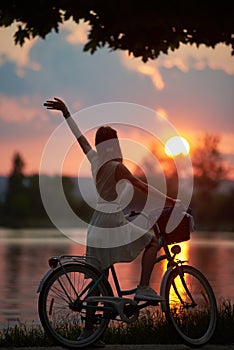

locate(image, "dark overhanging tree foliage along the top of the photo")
[[0, 0, 234, 62]]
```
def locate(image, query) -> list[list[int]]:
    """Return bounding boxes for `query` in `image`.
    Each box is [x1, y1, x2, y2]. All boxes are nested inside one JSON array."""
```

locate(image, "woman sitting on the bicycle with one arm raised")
[[44, 98, 179, 301]]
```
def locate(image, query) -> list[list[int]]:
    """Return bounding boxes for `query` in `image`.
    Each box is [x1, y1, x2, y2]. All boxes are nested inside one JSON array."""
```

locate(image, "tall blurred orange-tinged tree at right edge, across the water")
[[192, 134, 233, 230]]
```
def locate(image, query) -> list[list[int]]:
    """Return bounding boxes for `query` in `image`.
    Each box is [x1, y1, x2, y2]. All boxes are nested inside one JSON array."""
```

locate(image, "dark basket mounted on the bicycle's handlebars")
[[157, 208, 192, 245]]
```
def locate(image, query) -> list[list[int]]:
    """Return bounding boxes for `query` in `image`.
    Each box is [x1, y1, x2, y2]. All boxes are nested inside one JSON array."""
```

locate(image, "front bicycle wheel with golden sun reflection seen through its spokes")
[[165, 265, 217, 347]]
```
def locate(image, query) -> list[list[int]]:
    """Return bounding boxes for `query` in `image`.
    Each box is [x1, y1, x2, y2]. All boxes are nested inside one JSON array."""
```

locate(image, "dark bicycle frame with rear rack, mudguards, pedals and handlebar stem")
[[37, 227, 188, 323]]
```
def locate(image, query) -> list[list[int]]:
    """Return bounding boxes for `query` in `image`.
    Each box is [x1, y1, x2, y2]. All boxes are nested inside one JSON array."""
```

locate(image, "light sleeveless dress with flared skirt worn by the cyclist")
[[86, 150, 154, 270]]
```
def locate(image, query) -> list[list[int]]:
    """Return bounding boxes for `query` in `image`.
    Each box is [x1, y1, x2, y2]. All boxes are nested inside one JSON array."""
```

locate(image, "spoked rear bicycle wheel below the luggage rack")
[[38, 264, 110, 349]]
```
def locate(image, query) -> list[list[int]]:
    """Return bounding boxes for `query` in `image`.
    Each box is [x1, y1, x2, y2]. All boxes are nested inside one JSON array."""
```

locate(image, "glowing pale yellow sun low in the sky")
[[164, 136, 190, 157]]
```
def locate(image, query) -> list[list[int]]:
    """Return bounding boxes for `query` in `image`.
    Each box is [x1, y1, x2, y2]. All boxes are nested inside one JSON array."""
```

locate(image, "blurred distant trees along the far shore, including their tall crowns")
[[0, 135, 234, 231]]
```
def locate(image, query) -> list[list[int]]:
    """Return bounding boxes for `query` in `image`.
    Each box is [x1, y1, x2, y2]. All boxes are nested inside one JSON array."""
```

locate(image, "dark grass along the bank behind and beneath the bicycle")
[[0, 300, 234, 347]]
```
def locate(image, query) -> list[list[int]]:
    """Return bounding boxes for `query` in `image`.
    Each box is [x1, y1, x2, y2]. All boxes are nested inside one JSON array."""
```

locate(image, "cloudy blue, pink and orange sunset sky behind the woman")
[[0, 21, 234, 176]]
